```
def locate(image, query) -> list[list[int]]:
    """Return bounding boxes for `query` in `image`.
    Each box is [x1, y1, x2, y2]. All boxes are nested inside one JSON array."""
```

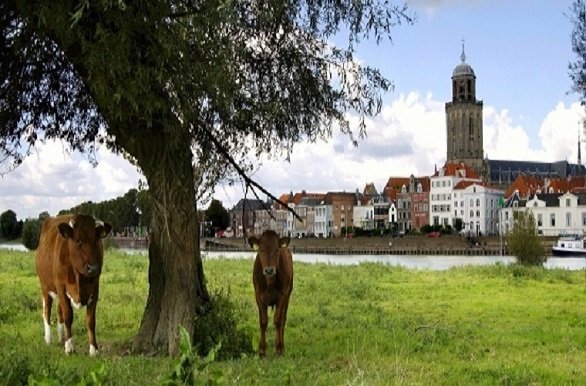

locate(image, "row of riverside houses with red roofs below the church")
[[225, 163, 586, 237]]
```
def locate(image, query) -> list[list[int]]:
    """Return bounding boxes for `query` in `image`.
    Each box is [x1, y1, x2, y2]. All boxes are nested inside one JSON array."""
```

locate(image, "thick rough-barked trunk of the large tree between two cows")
[[128, 129, 209, 355]]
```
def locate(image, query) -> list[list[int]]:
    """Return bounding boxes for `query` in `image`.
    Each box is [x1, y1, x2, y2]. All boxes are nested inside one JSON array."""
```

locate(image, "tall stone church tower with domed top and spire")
[[446, 43, 485, 175]]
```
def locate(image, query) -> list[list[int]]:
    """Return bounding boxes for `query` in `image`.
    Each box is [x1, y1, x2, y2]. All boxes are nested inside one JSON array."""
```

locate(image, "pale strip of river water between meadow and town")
[[0, 244, 586, 271]]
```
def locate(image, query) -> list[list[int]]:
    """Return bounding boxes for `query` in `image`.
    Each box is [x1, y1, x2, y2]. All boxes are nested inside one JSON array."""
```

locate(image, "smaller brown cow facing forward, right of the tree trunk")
[[248, 230, 293, 356]]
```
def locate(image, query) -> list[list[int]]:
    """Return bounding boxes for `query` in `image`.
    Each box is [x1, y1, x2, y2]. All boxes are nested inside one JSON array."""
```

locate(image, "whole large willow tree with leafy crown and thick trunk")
[[0, 0, 412, 354]]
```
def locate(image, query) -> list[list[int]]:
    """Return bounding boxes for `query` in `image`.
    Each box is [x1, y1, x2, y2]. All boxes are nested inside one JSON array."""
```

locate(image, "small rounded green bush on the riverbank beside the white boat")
[[507, 211, 546, 265]]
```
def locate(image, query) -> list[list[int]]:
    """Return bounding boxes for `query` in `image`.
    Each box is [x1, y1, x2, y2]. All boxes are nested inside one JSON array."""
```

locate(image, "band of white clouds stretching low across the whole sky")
[[0, 92, 586, 219]]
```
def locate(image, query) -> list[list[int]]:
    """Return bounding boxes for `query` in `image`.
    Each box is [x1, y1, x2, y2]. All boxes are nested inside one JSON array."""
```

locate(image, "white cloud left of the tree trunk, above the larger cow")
[[0, 141, 140, 219]]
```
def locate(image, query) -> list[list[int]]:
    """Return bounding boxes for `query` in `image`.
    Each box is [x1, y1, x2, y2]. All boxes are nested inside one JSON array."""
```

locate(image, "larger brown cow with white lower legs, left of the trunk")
[[35, 214, 112, 356]]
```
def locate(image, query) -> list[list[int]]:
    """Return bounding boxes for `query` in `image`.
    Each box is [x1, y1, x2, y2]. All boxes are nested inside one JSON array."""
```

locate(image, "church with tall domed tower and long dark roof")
[[446, 45, 586, 188]]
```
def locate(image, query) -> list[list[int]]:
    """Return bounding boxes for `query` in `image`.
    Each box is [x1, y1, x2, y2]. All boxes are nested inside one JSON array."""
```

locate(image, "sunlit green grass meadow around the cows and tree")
[[0, 250, 586, 385]]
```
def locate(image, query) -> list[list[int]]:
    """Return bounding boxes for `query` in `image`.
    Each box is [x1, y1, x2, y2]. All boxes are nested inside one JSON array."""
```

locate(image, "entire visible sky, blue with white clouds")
[[0, 0, 586, 219]]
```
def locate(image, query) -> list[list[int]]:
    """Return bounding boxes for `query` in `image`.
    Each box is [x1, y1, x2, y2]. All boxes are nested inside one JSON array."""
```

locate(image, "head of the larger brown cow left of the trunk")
[[58, 214, 112, 277]]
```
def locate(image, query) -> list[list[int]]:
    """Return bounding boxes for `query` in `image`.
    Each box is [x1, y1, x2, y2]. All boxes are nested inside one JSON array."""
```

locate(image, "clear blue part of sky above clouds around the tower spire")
[[378, 0, 576, 146]]
